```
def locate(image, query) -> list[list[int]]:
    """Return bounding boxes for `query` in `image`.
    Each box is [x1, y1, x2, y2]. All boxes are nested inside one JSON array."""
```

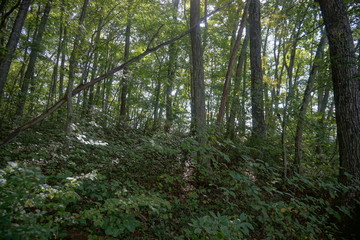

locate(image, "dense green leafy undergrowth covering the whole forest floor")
[[0, 122, 360, 240]]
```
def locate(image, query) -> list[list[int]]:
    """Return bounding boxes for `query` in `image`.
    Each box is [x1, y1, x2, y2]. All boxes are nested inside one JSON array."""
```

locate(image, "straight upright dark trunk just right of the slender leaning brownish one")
[[249, 0, 266, 138]]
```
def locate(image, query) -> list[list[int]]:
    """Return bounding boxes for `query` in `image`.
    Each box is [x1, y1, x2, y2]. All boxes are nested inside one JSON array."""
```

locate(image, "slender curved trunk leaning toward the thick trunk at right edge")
[[294, 33, 326, 173]]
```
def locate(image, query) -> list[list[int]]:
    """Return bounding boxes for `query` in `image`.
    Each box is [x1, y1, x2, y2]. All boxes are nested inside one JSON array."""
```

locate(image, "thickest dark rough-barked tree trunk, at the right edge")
[[317, 0, 360, 184]]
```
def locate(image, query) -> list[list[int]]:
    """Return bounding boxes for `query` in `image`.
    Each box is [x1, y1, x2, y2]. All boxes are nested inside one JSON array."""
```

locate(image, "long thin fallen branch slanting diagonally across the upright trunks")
[[0, 0, 234, 146]]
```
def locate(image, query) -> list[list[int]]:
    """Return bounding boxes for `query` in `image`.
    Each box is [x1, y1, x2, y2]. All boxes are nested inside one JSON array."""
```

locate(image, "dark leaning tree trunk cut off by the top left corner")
[[0, 0, 31, 99]]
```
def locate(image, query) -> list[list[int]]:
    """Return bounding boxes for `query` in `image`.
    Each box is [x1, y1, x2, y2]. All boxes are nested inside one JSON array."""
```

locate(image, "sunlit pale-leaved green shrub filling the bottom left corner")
[[0, 162, 79, 239]]
